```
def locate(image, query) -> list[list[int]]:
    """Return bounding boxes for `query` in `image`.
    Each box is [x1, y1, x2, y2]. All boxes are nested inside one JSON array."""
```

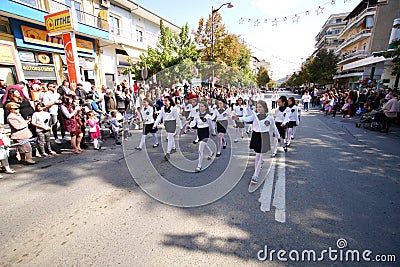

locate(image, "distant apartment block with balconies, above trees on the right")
[[313, 13, 349, 56]]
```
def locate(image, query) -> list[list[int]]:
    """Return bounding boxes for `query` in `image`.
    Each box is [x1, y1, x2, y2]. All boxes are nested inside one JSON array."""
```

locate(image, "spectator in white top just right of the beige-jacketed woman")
[[31, 103, 57, 158]]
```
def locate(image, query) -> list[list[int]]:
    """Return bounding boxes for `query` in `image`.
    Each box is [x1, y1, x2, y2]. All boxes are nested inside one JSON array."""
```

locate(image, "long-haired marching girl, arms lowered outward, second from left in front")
[[153, 96, 182, 160]]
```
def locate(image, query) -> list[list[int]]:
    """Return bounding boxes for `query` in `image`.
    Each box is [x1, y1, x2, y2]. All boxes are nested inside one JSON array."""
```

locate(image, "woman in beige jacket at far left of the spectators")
[[6, 102, 36, 165]]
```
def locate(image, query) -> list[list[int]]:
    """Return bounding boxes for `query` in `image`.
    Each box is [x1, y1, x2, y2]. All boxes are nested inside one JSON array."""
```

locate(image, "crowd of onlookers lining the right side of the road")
[[294, 88, 400, 133]]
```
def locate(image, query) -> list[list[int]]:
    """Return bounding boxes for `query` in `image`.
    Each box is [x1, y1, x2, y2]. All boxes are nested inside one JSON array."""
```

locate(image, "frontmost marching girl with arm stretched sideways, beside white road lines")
[[233, 100, 279, 183]]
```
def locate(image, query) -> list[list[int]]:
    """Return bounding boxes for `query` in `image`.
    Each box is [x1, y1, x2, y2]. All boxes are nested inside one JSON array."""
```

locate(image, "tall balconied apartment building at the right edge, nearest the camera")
[[334, 0, 400, 89]]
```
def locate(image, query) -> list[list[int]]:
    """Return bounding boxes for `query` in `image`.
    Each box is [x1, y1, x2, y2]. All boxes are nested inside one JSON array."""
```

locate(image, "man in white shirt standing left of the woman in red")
[[43, 83, 65, 144]]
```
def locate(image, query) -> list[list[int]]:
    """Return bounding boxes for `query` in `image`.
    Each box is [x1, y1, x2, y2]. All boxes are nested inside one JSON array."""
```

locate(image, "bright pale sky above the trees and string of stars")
[[133, 0, 361, 80]]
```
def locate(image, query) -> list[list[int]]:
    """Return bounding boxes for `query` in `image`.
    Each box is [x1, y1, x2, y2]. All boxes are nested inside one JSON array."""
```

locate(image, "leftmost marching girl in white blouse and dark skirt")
[[135, 98, 158, 150]]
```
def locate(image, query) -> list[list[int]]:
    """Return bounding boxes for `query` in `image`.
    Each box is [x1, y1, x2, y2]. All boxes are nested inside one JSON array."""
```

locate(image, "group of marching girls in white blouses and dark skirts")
[[136, 96, 301, 180]]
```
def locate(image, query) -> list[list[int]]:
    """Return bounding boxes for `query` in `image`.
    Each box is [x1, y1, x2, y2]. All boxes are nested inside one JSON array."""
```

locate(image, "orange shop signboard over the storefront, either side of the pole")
[[21, 25, 94, 53]]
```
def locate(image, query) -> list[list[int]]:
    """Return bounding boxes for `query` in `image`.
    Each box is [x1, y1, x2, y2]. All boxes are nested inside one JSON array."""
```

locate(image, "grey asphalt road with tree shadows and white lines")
[[0, 91, 400, 266]]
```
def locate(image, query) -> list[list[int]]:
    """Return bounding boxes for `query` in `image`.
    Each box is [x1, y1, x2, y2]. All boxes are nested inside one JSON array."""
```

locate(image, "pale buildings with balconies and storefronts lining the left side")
[[0, 0, 180, 90]]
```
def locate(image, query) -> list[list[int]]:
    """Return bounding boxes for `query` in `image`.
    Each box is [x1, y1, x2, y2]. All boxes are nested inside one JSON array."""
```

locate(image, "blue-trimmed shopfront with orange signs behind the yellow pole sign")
[[10, 18, 96, 87]]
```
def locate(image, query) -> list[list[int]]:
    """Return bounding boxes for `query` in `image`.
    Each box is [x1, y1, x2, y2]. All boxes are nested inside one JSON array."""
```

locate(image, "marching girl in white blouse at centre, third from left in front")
[[189, 101, 214, 172]]
